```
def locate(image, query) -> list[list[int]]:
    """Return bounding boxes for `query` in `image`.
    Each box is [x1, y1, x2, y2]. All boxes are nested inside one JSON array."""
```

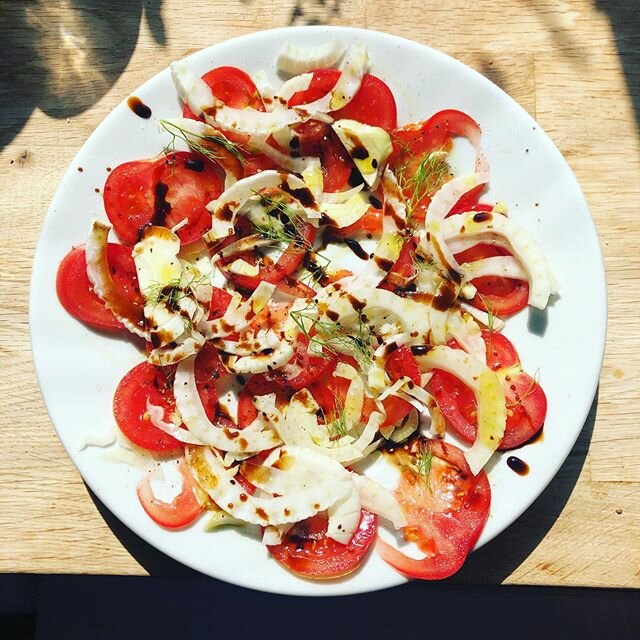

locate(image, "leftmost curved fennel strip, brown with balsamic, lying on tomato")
[[85, 220, 149, 340]]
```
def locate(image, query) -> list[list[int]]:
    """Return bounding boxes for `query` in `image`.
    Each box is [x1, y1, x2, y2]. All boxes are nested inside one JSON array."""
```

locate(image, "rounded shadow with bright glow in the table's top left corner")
[[0, 0, 166, 149]]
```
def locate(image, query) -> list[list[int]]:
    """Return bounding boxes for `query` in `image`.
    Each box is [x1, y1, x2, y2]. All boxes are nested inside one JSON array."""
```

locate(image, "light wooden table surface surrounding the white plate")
[[0, 0, 640, 587]]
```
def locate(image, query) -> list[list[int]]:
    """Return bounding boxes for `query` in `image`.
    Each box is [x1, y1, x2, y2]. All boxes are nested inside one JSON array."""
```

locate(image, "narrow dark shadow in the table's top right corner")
[[595, 0, 640, 127]]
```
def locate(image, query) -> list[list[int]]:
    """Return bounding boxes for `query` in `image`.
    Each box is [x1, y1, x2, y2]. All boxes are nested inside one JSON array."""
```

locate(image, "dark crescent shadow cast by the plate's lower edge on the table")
[[87, 393, 598, 589]]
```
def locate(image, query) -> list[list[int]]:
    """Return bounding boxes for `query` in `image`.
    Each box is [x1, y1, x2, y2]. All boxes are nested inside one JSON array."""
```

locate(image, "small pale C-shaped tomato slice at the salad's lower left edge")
[[136, 458, 203, 529]]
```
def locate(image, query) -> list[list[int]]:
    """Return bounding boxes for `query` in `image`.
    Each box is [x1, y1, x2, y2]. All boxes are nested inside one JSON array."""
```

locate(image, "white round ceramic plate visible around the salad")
[[30, 27, 606, 595]]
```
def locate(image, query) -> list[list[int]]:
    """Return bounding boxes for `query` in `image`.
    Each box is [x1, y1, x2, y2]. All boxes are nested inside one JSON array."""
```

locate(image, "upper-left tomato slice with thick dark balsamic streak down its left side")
[[152, 151, 223, 244]]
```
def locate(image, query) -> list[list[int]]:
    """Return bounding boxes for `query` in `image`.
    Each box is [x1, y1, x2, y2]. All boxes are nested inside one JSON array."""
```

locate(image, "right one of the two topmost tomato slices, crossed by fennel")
[[289, 69, 398, 130]]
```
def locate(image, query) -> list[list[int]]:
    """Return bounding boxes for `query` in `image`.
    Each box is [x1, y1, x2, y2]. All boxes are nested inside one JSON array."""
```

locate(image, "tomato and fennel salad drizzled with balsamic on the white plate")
[[56, 42, 557, 580]]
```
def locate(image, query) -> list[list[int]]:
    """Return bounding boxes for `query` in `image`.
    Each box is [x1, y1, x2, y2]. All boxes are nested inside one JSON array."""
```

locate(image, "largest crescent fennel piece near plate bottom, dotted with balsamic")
[[187, 446, 354, 526]]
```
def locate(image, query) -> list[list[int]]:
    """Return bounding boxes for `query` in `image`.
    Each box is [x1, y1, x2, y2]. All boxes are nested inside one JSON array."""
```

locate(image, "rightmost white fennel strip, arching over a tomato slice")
[[442, 211, 558, 309]]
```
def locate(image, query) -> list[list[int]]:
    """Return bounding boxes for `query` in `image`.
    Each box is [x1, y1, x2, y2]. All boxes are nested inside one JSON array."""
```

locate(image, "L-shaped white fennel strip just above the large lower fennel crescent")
[[173, 357, 280, 453]]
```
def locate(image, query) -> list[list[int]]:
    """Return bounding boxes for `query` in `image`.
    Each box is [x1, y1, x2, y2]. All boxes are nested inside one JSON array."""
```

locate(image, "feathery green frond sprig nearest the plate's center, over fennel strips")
[[289, 303, 373, 366]]
